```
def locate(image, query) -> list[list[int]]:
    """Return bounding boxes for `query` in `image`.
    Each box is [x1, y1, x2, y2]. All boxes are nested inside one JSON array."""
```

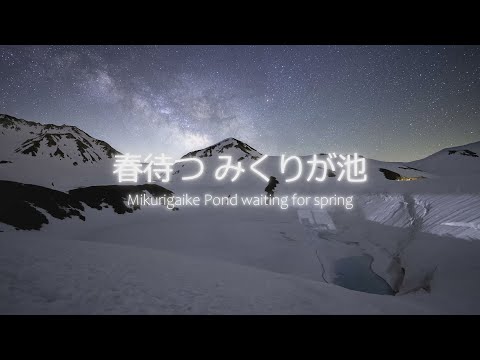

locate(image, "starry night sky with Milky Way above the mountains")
[[0, 45, 480, 161]]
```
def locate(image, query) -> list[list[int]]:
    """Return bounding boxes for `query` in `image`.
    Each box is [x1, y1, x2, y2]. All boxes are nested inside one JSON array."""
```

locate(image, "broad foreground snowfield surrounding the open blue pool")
[[0, 204, 480, 314]]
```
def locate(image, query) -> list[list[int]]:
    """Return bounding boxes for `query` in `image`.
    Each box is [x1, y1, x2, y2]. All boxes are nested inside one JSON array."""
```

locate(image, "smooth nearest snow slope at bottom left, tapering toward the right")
[[0, 229, 440, 314]]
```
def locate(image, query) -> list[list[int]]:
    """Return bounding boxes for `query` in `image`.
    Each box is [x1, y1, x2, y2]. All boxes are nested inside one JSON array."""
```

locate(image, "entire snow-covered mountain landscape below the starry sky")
[[0, 115, 480, 314]]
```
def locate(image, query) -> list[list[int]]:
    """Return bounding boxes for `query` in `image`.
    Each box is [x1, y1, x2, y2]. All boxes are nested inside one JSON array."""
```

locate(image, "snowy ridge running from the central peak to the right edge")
[[172, 138, 480, 192]]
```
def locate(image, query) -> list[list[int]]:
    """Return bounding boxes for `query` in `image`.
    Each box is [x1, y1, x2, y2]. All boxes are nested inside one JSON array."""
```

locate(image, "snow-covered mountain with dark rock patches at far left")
[[0, 114, 124, 190]]
